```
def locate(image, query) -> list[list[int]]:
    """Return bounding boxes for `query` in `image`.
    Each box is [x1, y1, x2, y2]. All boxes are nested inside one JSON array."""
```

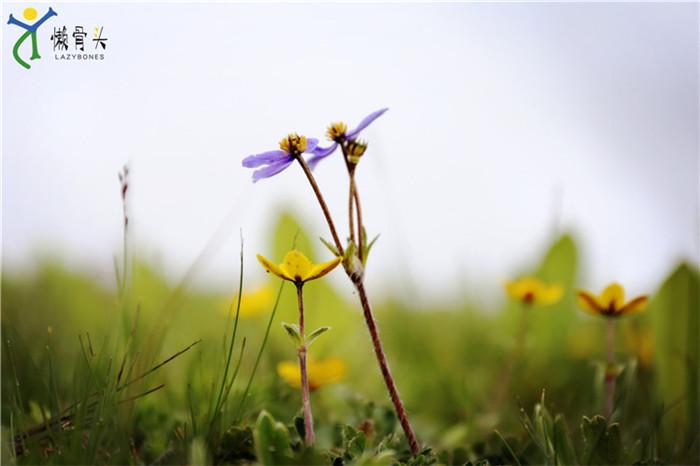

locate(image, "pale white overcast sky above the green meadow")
[[2, 3, 699, 306]]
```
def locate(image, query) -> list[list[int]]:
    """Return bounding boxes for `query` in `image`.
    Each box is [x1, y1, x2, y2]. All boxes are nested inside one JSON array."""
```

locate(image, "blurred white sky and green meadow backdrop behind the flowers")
[[2, 3, 700, 464]]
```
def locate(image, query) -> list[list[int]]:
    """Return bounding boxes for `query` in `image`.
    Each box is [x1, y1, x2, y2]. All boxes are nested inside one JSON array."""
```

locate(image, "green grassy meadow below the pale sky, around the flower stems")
[[2, 215, 700, 465]]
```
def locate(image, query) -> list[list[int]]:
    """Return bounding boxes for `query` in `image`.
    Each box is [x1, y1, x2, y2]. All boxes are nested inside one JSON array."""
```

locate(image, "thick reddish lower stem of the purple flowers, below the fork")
[[355, 279, 420, 455]]
